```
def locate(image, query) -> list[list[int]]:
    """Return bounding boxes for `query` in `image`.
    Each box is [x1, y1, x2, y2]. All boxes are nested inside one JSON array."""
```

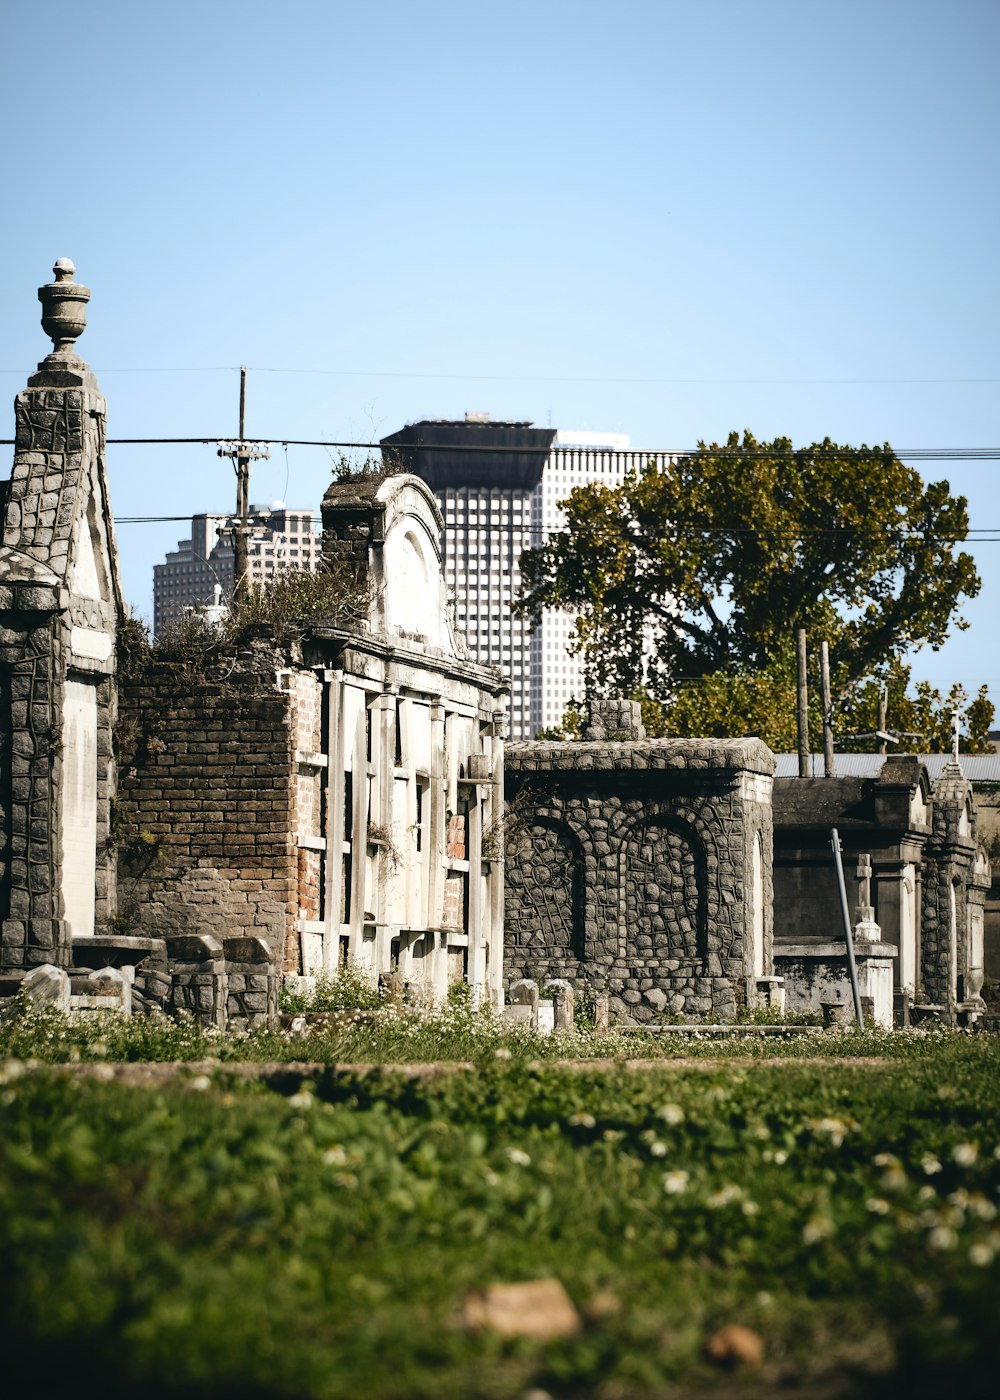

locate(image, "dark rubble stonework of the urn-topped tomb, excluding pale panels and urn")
[[0, 364, 122, 972]]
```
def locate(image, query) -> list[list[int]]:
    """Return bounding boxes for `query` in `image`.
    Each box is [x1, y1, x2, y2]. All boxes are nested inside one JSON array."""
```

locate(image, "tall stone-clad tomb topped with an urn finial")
[[0, 258, 122, 972]]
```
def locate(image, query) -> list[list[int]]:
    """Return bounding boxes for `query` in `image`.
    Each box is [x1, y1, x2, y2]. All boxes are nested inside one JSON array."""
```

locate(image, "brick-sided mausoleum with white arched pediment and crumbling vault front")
[[120, 475, 506, 1001]]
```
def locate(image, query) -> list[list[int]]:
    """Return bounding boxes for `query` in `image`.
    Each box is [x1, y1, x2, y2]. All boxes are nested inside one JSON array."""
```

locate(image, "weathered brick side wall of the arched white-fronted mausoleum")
[[119, 666, 298, 970]]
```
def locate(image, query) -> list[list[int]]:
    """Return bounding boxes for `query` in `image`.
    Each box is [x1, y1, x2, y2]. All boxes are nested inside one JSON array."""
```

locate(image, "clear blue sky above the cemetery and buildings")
[[0, 0, 1000, 707]]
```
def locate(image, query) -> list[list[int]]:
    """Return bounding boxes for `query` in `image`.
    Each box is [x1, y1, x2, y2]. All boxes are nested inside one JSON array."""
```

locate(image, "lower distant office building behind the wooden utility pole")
[[153, 501, 321, 636]]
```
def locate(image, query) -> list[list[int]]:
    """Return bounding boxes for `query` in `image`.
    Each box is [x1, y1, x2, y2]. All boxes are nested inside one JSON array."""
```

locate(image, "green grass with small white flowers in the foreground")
[[0, 1026, 1000, 1400]]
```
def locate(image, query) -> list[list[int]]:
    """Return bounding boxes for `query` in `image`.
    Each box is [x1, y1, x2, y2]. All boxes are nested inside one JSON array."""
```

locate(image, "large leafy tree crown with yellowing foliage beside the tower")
[[518, 433, 980, 706]]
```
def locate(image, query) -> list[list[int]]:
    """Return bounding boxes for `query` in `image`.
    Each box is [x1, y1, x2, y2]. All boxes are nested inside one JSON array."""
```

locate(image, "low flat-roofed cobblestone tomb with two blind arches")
[[504, 739, 775, 1022]]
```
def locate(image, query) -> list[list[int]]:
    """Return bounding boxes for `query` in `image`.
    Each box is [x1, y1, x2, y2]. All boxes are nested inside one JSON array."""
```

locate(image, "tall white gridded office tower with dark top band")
[[381, 414, 647, 739]]
